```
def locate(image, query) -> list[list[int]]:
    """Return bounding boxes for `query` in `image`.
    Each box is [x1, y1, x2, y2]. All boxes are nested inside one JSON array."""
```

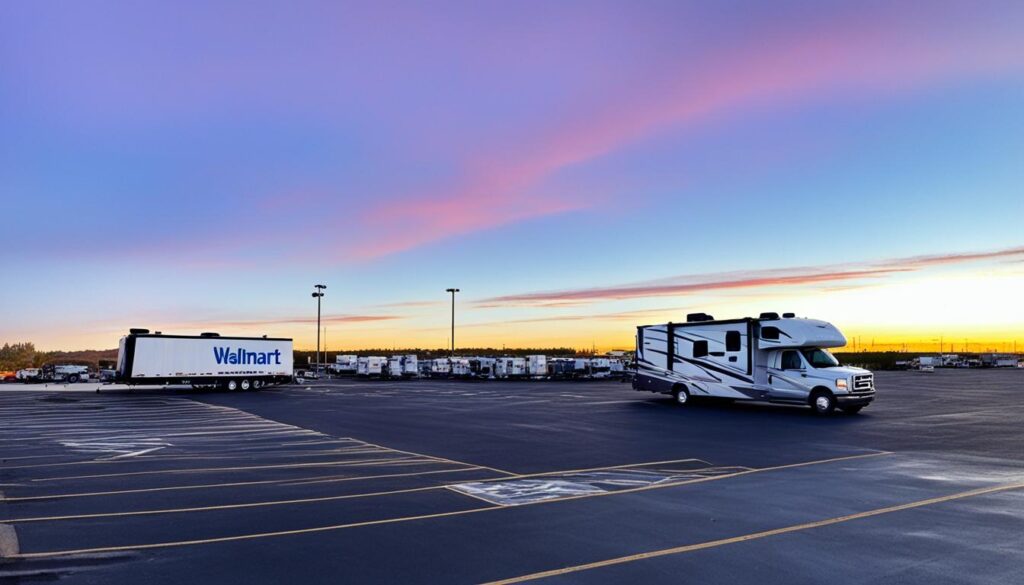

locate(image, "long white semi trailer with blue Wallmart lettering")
[[114, 329, 293, 390]]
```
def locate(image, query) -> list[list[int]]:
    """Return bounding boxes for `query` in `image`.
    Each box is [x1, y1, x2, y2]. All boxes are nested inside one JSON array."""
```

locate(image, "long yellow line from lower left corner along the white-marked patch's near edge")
[[6, 452, 891, 558]]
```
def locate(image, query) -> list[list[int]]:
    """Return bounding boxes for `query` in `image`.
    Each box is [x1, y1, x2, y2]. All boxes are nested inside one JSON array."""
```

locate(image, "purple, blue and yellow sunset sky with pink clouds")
[[0, 0, 1024, 350]]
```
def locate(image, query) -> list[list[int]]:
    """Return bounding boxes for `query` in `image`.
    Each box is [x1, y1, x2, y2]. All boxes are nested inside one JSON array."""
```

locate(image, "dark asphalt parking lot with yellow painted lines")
[[0, 370, 1024, 585]]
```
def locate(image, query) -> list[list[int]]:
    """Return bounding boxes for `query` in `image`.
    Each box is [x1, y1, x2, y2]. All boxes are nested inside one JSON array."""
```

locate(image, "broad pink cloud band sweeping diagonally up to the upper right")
[[346, 20, 1024, 258]]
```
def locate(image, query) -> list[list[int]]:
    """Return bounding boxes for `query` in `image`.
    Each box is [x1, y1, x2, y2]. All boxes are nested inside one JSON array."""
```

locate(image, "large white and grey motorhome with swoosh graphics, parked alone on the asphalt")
[[633, 312, 874, 415]]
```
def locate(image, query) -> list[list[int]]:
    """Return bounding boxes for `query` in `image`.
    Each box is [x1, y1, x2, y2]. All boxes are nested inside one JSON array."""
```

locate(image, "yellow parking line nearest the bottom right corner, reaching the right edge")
[[485, 482, 1024, 585]]
